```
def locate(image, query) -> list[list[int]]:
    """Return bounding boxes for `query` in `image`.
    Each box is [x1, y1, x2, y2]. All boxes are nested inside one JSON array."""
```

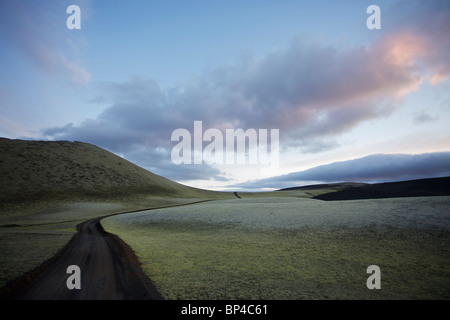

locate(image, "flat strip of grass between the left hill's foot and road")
[[0, 197, 214, 286]]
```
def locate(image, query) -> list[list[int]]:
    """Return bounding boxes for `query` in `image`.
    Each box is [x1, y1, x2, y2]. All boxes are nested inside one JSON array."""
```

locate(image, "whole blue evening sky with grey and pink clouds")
[[0, 0, 450, 190]]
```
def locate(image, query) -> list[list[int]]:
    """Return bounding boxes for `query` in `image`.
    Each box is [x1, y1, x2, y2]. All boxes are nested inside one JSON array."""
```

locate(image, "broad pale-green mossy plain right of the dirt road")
[[102, 197, 450, 300]]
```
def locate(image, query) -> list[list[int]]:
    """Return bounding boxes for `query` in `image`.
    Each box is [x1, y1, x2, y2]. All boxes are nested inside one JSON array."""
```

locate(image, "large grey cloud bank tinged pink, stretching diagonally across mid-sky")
[[43, 1, 450, 179]]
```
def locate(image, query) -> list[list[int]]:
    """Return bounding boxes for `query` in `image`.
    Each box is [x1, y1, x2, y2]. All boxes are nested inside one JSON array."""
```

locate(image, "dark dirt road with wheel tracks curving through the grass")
[[3, 218, 161, 300]]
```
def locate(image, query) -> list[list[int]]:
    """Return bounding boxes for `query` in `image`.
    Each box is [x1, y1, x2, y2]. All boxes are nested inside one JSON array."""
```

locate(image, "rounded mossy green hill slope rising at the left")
[[0, 138, 225, 202]]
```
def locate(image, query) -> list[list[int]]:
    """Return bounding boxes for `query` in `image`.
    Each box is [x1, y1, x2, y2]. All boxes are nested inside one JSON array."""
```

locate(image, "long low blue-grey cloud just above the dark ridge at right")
[[235, 152, 450, 189]]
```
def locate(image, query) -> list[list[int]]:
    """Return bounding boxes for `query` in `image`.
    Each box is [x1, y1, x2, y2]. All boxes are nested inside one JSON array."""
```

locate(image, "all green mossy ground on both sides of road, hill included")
[[0, 138, 450, 299]]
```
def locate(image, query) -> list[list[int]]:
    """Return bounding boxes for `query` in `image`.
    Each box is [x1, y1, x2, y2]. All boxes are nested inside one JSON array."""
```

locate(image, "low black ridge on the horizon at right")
[[313, 177, 450, 201]]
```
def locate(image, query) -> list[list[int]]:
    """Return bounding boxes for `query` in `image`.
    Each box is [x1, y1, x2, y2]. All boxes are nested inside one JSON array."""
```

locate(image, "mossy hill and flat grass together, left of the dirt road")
[[0, 138, 235, 286]]
